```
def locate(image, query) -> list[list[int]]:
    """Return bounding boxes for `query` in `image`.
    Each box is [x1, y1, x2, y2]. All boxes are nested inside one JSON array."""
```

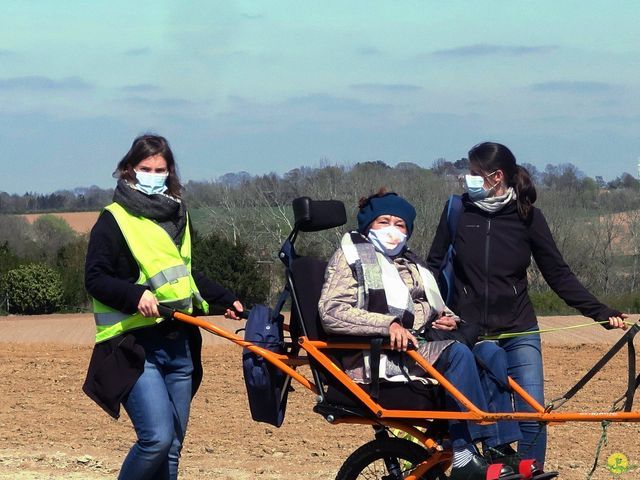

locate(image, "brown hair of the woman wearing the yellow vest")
[[113, 134, 182, 198]]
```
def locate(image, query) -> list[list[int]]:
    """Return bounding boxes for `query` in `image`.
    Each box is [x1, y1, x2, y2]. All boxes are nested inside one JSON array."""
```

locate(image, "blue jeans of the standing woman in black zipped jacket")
[[498, 325, 547, 465]]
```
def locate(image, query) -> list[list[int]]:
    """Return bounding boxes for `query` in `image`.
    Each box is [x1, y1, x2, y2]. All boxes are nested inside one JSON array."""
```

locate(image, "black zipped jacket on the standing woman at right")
[[427, 194, 620, 334]]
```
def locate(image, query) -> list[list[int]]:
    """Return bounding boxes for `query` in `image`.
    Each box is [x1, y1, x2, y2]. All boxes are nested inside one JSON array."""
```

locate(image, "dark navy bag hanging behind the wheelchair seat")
[[242, 305, 290, 427]]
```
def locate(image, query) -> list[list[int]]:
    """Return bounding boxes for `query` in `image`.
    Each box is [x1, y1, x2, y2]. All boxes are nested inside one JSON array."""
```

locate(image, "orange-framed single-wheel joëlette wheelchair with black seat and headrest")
[[161, 197, 640, 480]]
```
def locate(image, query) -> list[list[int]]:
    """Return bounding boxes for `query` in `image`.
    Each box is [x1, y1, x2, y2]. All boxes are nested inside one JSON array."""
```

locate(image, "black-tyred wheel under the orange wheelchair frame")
[[336, 438, 447, 480]]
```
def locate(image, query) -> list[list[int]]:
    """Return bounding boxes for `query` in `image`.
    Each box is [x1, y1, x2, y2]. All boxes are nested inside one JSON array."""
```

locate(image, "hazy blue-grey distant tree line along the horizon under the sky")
[[0, 158, 640, 214]]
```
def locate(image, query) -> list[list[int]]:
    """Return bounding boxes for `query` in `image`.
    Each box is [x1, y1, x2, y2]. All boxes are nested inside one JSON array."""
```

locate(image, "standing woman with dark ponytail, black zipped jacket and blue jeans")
[[427, 142, 626, 465]]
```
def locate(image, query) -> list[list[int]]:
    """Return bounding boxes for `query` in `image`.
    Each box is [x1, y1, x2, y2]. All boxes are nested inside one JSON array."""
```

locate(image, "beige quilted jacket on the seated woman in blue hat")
[[318, 248, 453, 383]]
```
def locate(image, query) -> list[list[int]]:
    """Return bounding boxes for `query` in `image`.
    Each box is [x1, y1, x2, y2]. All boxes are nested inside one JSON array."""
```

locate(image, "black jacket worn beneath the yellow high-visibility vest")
[[82, 210, 237, 418]]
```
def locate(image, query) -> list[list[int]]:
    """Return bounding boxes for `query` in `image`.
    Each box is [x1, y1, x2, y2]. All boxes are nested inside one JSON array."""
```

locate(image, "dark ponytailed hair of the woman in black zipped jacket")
[[469, 142, 538, 220]]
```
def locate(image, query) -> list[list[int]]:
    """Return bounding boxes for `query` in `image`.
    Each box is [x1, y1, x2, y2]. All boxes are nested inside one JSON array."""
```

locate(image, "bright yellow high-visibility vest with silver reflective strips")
[[93, 202, 209, 343]]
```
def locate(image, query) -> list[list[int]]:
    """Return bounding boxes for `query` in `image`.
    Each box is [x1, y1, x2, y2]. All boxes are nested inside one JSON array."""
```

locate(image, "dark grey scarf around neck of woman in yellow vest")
[[113, 179, 187, 245]]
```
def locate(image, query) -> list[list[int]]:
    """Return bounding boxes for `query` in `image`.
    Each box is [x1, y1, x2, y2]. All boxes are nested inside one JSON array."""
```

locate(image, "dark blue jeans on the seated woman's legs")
[[434, 342, 521, 447]]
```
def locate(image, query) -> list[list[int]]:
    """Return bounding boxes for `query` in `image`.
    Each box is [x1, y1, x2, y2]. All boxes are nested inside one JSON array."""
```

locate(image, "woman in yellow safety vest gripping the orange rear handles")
[[83, 135, 243, 480]]
